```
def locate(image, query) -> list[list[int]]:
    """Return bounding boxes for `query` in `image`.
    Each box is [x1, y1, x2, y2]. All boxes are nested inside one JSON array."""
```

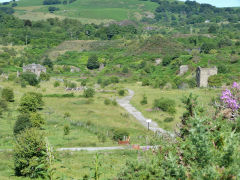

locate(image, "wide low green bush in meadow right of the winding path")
[[153, 98, 176, 114]]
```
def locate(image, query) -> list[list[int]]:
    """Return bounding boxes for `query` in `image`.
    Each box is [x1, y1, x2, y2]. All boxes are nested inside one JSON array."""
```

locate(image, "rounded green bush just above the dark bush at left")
[[18, 92, 44, 113]]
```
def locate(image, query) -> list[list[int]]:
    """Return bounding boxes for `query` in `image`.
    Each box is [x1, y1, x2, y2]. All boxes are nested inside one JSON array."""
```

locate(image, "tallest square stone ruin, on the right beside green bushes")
[[196, 67, 218, 87]]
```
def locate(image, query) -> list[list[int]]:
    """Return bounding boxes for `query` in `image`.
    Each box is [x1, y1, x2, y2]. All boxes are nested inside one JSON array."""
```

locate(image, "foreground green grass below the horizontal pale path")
[[0, 150, 141, 180]]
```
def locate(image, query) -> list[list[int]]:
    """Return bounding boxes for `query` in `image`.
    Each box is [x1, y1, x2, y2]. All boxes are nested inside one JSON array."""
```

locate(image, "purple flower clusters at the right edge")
[[221, 82, 240, 111]]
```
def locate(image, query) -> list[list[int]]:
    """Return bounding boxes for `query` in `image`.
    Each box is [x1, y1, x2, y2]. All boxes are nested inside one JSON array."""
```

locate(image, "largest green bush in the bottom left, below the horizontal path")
[[13, 128, 50, 179]]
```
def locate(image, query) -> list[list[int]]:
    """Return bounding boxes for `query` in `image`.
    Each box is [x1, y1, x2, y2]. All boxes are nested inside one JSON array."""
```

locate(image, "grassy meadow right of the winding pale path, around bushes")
[[126, 83, 220, 131]]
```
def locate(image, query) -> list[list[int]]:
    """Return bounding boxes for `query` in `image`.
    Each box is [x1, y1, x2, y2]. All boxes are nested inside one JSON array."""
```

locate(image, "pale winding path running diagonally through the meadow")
[[117, 89, 174, 137]]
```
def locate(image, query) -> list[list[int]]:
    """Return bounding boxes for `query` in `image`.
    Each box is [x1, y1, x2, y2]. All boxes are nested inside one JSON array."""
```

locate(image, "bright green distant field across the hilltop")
[[15, 0, 157, 23]]
